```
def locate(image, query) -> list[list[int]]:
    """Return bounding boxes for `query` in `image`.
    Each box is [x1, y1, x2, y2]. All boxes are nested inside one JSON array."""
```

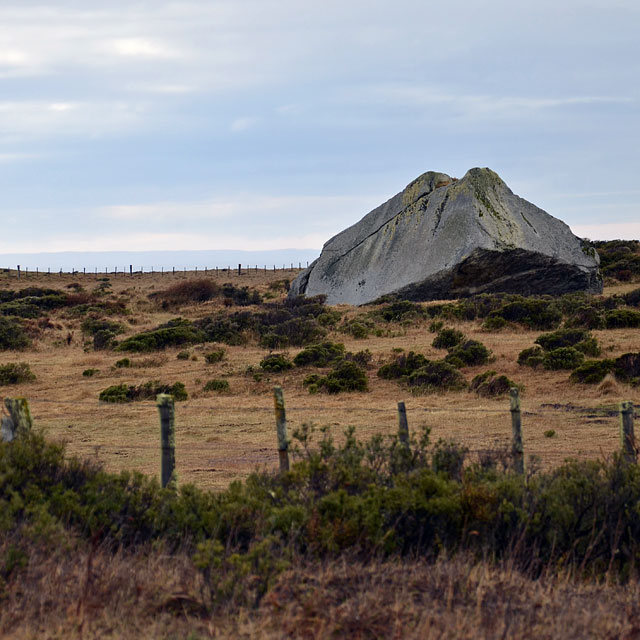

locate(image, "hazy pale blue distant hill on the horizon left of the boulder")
[[0, 249, 320, 271]]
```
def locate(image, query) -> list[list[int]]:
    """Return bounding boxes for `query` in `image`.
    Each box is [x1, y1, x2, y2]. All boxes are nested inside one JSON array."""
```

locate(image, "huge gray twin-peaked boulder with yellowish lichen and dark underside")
[[289, 169, 602, 305]]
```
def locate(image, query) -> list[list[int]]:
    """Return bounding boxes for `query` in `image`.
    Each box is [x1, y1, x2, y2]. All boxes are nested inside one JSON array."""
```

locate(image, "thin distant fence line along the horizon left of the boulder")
[[3, 260, 309, 279]]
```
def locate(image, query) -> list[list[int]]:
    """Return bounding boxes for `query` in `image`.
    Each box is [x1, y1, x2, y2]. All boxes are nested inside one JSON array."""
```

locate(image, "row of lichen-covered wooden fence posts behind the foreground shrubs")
[[1, 386, 638, 487]]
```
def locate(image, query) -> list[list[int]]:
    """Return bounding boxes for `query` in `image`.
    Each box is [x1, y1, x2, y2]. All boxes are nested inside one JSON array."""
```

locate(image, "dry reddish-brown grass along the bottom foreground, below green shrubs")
[[0, 550, 640, 640]]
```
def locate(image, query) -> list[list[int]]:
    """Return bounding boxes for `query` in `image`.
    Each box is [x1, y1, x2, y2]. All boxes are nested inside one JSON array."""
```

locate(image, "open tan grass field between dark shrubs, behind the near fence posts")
[[0, 270, 640, 488]]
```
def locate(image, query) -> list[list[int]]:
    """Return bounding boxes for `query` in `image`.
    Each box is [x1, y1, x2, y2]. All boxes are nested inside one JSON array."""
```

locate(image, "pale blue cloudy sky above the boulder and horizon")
[[0, 0, 640, 260]]
